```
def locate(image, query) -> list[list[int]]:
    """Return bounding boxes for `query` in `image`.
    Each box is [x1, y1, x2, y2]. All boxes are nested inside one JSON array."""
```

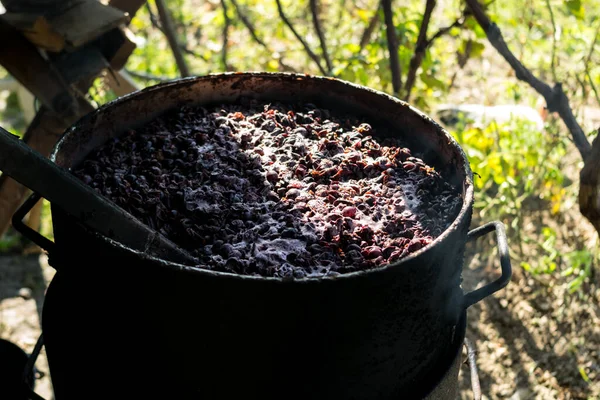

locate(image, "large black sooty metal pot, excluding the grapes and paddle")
[[43, 73, 473, 400]]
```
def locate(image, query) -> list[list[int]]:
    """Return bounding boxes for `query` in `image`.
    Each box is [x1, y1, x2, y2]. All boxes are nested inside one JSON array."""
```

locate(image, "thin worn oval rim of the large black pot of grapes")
[[50, 71, 474, 283]]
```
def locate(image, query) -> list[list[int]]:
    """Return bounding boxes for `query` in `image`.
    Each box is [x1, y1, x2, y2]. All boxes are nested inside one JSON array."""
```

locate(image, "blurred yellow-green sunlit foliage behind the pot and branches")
[[0, 0, 600, 293]]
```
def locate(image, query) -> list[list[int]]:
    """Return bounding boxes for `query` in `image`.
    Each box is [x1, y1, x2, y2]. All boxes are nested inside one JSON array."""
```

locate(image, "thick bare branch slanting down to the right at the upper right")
[[466, 0, 592, 161]]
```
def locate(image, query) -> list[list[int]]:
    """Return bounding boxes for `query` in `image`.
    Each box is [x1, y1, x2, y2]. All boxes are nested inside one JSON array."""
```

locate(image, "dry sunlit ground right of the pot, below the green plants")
[[461, 245, 600, 400]]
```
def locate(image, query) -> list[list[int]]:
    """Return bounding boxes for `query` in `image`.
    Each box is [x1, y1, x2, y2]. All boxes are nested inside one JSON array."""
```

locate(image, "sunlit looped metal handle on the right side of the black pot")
[[464, 221, 512, 308]]
